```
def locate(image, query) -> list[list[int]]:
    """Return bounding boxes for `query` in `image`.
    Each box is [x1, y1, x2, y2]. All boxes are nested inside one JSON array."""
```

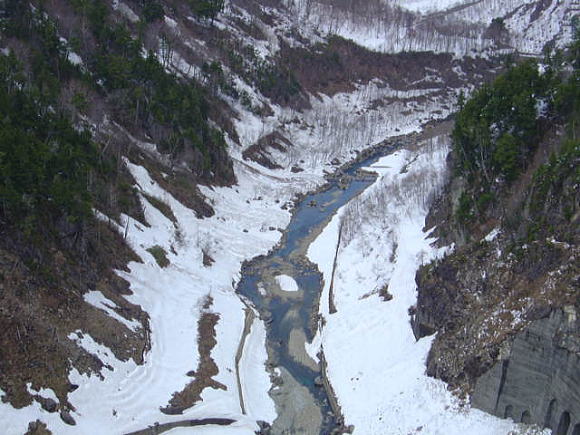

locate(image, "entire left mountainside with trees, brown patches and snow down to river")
[[0, 0, 575, 433]]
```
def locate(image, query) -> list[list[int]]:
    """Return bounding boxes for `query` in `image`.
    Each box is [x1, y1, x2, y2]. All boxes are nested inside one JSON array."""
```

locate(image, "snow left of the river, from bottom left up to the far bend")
[[0, 74, 462, 434]]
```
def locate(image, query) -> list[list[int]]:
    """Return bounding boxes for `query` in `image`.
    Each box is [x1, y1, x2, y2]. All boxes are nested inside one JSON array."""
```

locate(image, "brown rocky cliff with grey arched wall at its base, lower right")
[[412, 232, 580, 435]]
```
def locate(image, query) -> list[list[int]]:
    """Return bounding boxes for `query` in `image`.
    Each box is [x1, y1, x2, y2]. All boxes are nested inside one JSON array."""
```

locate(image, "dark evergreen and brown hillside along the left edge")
[[0, 1, 235, 422]]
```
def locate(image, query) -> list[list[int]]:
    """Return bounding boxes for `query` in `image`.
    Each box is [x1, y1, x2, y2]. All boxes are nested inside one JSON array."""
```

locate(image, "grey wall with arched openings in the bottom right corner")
[[472, 307, 580, 435]]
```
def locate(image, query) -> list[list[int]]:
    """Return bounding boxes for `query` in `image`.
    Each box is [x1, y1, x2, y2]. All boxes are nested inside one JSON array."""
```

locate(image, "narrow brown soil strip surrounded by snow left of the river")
[[161, 296, 227, 415]]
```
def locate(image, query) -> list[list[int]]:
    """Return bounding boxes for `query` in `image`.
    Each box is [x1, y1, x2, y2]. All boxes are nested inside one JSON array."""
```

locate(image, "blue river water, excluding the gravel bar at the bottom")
[[237, 145, 394, 434]]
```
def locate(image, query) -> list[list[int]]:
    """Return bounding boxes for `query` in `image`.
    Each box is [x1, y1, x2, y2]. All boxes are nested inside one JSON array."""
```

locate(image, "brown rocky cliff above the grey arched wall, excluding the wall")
[[414, 221, 579, 402]]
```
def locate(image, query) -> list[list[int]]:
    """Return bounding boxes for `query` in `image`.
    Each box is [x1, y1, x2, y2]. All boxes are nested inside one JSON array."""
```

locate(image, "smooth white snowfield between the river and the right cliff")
[[307, 137, 547, 435]]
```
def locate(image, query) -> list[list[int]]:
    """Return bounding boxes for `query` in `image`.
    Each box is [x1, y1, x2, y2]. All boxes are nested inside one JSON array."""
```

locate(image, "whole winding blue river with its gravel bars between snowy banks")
[[237, 142, 408, 434]]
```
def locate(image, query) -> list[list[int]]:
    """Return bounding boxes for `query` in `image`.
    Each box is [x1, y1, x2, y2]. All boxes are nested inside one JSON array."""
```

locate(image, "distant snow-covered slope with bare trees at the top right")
[[286, 0, 578, 56]]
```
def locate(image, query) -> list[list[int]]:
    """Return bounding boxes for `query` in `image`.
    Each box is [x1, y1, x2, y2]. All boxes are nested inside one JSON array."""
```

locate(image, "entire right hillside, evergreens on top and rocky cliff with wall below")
[[413, 33, 580, 433]]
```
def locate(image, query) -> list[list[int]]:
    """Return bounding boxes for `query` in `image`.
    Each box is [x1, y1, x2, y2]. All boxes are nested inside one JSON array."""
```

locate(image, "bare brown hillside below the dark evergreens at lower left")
[[0, 222, 149, 412]]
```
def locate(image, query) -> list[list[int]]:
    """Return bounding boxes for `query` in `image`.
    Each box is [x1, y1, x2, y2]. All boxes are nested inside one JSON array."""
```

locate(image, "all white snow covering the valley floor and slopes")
[[0, 0, 571, 434]]
